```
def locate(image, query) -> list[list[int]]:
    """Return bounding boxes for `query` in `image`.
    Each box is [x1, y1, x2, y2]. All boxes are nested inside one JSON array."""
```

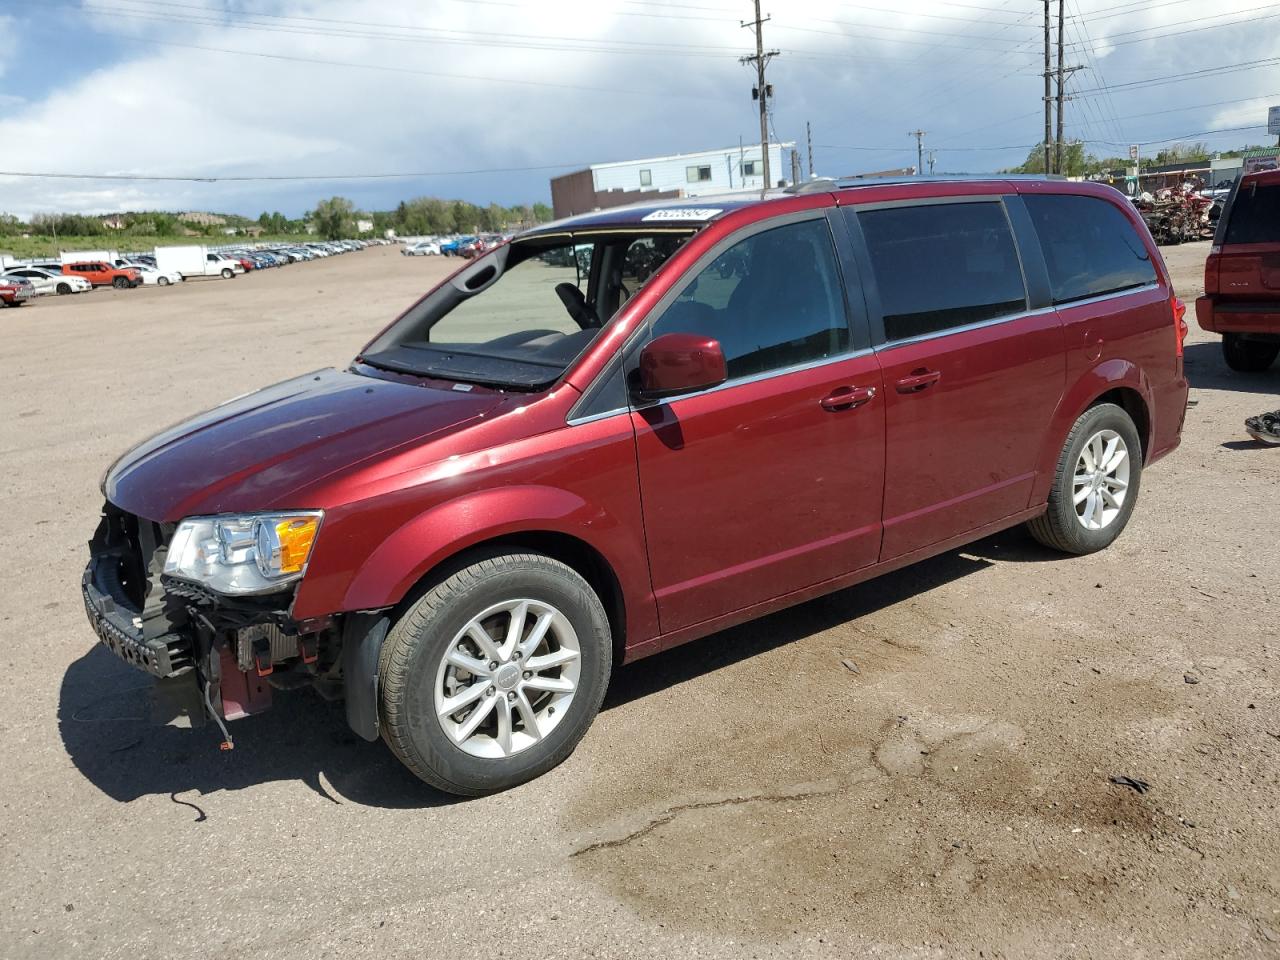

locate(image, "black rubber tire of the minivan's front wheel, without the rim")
[[379, 553, 613, 796]]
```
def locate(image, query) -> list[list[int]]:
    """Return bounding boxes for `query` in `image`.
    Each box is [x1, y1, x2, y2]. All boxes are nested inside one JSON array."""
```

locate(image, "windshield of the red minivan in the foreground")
[[362, 229, 692, 389]]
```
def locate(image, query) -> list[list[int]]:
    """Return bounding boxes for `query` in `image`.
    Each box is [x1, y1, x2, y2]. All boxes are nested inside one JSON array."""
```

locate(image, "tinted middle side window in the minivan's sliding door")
[[856, 202, 1027, 340]]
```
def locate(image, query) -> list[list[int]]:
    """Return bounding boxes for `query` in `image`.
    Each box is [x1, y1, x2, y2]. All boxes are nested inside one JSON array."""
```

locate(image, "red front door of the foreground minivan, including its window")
[[631, 211, 884, 632]]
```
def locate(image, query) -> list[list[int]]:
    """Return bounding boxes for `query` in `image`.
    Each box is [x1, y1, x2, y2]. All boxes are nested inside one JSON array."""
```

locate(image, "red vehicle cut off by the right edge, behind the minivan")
[[1196, 170, 1280, 372]]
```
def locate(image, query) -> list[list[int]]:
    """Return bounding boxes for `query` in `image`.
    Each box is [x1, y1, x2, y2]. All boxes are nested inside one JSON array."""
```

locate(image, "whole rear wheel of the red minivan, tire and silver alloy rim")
[[1027, 403, 1142, 554]]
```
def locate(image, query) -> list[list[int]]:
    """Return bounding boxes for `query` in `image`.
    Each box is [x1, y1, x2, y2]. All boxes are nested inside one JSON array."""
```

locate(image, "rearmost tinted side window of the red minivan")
[[1023, 196, 1156, 303]]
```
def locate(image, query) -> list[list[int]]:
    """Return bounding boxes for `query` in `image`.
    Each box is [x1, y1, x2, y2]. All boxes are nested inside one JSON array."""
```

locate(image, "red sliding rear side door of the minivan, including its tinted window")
[[846, 198, 1066, 559]]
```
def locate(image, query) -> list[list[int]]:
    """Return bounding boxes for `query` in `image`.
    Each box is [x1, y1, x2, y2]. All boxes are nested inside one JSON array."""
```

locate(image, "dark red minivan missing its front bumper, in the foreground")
[[82, 178, 1187, 794]]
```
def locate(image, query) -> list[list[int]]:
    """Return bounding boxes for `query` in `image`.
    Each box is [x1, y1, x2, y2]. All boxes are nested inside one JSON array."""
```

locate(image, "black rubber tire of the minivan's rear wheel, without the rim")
[[1027, 403, 1142, 556]]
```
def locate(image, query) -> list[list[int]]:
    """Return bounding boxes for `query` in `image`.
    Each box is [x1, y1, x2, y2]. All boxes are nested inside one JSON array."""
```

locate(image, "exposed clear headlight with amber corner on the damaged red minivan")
[[164, 509, 324, 595]]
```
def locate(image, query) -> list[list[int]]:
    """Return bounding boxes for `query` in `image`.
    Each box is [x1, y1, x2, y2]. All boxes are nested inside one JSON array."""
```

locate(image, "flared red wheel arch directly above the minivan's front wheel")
[[342, 484, 634, 611]]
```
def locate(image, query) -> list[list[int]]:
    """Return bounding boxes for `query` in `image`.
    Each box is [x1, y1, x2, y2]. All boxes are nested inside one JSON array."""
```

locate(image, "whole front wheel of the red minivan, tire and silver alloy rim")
[[379, 553, 613, 796]]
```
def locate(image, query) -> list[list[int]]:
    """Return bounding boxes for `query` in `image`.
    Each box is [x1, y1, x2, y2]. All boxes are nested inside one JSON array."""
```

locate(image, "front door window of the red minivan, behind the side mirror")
[[653, 220, 849, 379]]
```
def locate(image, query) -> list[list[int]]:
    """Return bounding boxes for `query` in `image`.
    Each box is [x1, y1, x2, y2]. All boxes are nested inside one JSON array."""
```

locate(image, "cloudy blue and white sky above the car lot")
[[0, 0, 1280, 216]]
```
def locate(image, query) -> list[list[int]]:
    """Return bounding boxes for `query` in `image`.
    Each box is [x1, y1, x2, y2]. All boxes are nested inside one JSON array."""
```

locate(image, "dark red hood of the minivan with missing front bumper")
[[102, 369, 504, 522]]
